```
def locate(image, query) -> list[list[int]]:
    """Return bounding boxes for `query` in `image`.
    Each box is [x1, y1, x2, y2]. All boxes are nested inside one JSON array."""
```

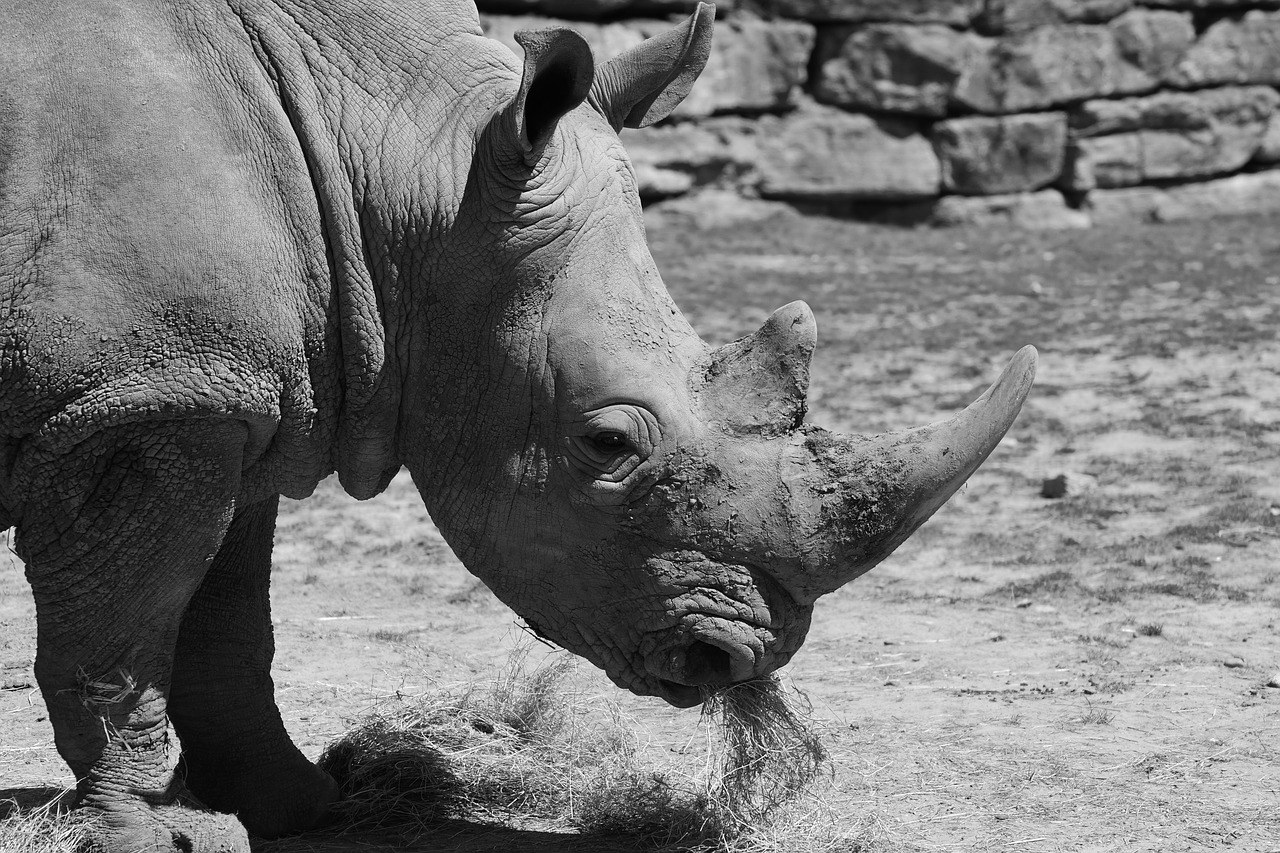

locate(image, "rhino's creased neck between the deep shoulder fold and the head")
[[228, 0, 517, 498]]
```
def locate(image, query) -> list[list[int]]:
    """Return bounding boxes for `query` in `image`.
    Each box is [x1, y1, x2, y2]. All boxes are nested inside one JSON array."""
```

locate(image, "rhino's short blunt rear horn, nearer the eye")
[[696, 302, 818, 435]]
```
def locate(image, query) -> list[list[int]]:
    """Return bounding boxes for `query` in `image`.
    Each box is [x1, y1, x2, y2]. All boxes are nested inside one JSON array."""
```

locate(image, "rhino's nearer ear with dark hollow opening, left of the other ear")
[[511, 27, 595, 154]]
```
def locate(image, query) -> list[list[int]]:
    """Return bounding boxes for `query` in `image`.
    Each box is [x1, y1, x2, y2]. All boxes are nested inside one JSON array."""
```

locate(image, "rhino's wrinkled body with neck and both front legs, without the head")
[[0, 0, 552, 853]]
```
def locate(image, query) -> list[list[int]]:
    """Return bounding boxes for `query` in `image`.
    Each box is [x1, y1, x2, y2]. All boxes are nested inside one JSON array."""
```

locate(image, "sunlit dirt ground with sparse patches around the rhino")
[[0, 207, 1280, 853]]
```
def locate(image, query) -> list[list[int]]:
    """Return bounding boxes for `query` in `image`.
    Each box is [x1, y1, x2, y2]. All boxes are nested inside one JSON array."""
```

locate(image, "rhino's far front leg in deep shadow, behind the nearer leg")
[[169, 497, 338, 838]]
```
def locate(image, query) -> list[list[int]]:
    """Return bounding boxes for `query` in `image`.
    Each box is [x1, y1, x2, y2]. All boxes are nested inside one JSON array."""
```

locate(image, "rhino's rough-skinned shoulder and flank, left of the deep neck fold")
[[0, 0, 338, 502]]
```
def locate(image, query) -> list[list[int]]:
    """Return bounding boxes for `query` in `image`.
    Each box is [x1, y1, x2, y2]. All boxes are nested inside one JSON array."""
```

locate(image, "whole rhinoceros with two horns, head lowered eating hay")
[[0, 0, 1036, 853]]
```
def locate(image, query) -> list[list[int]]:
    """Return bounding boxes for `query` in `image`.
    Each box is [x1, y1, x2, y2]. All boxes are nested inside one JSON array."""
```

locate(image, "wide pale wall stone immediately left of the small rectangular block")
[[756, 105, 941, 202]]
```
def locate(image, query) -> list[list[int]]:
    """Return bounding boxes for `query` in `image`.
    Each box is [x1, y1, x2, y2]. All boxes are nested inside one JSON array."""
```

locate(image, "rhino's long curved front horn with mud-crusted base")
[[785, 347, 1037, 601]]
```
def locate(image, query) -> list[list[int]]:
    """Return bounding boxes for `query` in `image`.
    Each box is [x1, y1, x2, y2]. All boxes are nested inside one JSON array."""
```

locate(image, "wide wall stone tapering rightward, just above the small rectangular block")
[[954, 24, 1157, 114]]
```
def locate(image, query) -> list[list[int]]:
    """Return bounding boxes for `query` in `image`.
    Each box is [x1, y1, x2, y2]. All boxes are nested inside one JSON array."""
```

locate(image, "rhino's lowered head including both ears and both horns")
[[399, 5, 1036, 707]]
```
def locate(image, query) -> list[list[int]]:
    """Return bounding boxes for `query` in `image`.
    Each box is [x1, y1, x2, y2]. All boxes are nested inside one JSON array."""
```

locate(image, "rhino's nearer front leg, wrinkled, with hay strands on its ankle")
[[15, 421, 248, 853]]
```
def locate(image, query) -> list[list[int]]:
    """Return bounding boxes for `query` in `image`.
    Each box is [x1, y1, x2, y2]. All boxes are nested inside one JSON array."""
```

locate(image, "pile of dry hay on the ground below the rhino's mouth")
[[320, 654, 828, 850]]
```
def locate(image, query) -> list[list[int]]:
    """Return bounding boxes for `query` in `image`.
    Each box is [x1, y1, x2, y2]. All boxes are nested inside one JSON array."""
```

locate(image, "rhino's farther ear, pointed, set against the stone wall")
[[589, 3, 716, 131]]
